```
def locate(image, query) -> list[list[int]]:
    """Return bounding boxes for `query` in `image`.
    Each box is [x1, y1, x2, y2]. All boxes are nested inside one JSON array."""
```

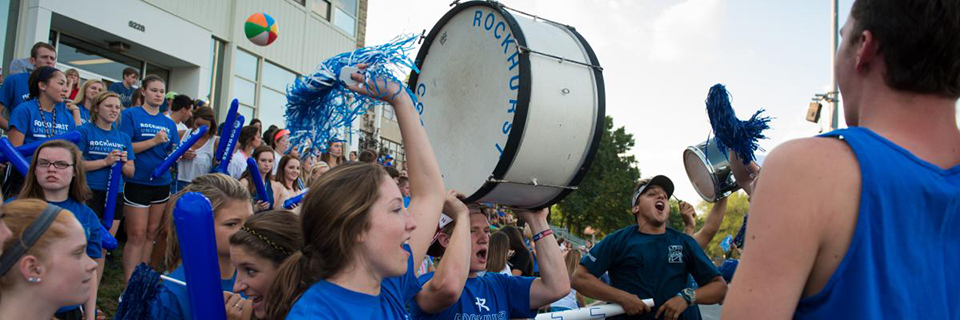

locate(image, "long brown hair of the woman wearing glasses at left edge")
[[19, 139, 91, 203]]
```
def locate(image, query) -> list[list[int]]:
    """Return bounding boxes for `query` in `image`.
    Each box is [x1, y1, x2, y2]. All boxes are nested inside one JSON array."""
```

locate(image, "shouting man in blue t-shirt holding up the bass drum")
[[410, 205, 570, 319]]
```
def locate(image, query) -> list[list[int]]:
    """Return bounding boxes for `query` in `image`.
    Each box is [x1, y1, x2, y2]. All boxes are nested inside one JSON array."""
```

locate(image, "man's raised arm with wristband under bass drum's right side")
[[514, 208, 570, 308]]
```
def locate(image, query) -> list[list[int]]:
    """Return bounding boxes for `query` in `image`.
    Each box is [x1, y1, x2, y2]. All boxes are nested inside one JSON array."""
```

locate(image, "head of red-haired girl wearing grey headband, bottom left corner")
[[0, 199, 97, 320]]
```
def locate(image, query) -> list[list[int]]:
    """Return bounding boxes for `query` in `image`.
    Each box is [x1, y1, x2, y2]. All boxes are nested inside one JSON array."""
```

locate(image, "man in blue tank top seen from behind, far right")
[[723, 0, 960, 319]]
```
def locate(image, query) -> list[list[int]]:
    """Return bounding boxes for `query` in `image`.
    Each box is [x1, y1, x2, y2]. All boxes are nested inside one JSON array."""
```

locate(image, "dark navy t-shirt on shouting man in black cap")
[[580, 225, 720, 320]]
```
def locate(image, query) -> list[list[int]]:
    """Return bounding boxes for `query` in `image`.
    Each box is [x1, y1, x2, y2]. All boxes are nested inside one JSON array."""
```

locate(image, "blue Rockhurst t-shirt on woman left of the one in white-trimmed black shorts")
[[77, 123, 137, 192]]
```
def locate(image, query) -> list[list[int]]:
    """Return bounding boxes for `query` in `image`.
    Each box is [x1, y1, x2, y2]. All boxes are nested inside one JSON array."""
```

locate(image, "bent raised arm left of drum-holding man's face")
[[414, 191, 472, 313]]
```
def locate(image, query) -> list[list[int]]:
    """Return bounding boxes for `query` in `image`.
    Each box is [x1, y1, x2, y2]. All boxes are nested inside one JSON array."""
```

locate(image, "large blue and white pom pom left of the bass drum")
[[285, 35, 419, 151]]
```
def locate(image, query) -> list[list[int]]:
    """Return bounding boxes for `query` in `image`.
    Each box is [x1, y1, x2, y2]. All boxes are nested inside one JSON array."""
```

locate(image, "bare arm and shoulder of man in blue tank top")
[[723, 138, 860, 319]]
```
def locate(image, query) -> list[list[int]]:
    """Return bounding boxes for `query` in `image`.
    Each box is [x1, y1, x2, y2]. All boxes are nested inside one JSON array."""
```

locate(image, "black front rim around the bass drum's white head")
[[407, 1, 531, 202]]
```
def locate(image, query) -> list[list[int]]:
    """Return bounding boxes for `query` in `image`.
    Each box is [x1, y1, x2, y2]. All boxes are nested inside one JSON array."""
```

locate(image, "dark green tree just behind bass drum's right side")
[[551, 116, 640, 238]]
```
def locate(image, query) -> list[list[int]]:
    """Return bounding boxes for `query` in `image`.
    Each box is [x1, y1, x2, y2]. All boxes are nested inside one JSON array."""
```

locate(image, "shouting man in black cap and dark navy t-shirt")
[[573, 176, 727, 320]]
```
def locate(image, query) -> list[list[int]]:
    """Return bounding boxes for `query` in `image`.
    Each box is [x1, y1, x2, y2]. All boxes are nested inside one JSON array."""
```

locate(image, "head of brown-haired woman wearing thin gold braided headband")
[[224, 210, 303, 319]]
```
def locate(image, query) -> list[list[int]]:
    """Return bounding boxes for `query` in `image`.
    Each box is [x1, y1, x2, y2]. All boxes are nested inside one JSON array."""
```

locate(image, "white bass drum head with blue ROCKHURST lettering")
[[410, 2, 529, 200]]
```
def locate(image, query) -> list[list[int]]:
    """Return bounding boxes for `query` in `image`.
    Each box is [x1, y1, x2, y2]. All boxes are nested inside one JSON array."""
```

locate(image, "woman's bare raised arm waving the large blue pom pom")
[[348, 65, 446, 265]]
